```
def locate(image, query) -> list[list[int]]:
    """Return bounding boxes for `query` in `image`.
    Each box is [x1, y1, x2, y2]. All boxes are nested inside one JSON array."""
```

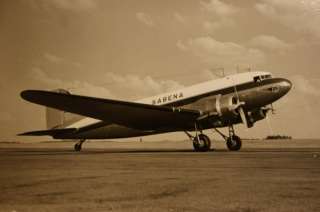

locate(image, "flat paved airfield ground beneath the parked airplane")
[[0, 141, 320, 212]]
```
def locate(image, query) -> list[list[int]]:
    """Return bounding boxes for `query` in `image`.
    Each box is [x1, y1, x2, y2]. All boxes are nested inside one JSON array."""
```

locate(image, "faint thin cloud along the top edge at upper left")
[[31, 0, 97, 11]]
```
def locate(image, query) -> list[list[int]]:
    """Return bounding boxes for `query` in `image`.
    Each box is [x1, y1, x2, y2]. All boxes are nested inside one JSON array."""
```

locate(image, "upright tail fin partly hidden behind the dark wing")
[[46, 89, 83, 129]]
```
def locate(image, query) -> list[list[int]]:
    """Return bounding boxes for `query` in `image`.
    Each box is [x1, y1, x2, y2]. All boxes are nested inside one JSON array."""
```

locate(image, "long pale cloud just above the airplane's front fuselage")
[[181, 36, 265, 68]]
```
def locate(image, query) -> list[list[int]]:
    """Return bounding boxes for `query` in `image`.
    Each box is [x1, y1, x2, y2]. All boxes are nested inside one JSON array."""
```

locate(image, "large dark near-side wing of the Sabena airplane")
[[21, 90, 200, 130]]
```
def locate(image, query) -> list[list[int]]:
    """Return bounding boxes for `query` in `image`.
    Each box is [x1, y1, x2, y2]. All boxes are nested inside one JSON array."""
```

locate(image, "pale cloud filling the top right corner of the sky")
[[255, 0, 320, 38]]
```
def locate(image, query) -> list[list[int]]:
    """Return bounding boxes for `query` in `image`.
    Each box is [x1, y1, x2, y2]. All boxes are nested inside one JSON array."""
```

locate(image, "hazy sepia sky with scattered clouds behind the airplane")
[[0, 0, 320, 141]]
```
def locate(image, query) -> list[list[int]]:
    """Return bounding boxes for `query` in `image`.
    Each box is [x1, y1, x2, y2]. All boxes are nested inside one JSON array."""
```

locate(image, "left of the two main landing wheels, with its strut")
[[185, 124, 211, 152]]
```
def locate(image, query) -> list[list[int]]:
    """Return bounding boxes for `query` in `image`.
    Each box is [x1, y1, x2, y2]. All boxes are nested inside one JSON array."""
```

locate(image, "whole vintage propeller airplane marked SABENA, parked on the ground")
[[19, 72, 292, 151]]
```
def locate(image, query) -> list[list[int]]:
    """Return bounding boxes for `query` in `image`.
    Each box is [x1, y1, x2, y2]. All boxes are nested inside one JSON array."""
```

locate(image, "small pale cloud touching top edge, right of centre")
[[201, 0, 238, 17]]
